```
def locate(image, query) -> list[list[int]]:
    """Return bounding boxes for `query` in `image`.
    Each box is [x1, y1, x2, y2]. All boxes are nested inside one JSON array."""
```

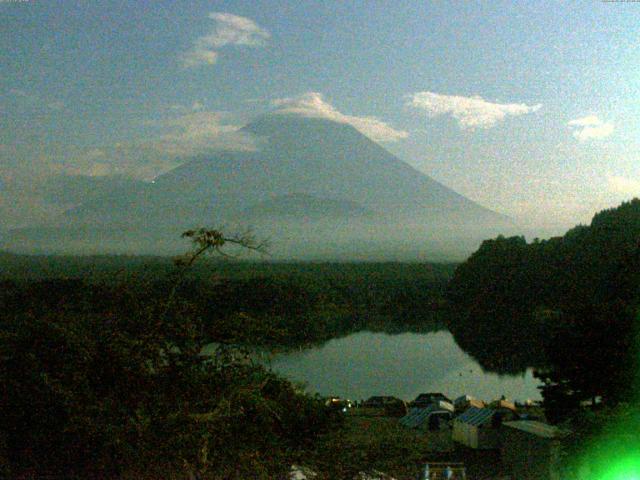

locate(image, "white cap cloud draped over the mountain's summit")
[[272, 92, 409, 142]]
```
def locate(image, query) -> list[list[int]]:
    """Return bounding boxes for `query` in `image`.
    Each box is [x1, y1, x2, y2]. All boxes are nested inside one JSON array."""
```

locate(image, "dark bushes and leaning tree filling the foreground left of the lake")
[[0, 231, 356, 479]]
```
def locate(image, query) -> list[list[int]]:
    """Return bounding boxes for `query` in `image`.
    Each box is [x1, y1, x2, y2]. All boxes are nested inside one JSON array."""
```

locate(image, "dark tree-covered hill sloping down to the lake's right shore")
[[448, 199, 640, 420]]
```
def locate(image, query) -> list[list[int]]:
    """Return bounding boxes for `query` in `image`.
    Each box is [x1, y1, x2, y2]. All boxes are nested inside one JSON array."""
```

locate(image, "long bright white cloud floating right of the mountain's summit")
[[407, 92, 542, 129]]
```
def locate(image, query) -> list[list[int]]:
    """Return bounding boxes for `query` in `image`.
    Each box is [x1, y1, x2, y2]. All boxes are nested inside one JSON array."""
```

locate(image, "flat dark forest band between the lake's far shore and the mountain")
[[0, 257, 453, 348]]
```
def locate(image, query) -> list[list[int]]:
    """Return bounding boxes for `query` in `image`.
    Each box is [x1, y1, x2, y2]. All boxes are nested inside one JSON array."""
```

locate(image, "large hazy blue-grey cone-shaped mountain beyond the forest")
[[2, 114, 509, 259]]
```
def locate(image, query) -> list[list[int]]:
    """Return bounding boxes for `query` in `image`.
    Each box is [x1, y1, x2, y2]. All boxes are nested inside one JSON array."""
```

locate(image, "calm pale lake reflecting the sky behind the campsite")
[[266, 331, 540, 401]]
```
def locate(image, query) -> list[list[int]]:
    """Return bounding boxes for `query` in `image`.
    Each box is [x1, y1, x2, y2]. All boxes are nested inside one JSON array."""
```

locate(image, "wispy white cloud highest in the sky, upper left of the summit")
[[180, 12, 271, 68]]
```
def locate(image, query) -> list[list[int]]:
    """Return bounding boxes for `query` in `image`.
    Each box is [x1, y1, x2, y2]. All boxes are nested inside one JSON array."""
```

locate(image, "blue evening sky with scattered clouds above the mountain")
[[0, 0, 640, 231]]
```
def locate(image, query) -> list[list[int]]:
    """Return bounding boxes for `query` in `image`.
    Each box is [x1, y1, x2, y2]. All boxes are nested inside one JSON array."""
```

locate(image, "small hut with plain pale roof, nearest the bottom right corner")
[[501, 420, 568, 480]]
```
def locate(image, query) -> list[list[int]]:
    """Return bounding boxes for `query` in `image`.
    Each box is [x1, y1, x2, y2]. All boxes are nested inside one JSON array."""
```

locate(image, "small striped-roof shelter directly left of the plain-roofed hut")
[[453, 407, 500, 450]]
